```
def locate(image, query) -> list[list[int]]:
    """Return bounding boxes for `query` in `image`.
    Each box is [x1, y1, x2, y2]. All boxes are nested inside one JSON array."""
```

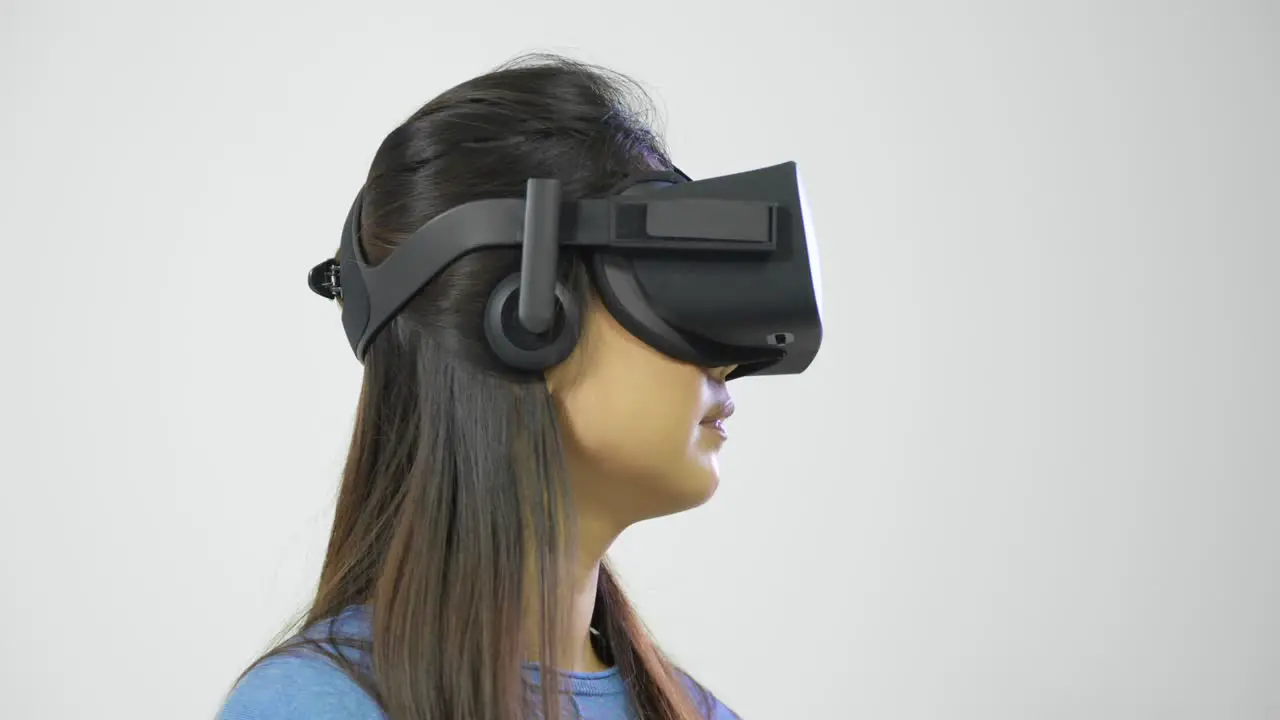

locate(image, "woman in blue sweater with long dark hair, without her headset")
[[220, 58, 735, 720]]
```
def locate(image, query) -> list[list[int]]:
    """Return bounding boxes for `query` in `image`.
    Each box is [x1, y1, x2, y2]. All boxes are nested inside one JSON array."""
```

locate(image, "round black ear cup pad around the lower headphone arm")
[[484, 273, 582, 373]]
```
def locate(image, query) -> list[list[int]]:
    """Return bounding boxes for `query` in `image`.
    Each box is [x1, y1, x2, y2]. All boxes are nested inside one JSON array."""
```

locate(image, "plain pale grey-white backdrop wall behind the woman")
[[0, 0, 1280, 720]]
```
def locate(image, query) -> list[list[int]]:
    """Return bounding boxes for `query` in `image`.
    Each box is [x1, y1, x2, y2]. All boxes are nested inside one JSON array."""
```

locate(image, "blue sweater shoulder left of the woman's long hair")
[[218, 653, 385, 720]]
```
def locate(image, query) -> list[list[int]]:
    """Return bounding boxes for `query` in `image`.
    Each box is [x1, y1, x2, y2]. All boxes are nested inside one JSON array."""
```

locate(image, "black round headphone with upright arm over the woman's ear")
[[484, 179, 582, 372]]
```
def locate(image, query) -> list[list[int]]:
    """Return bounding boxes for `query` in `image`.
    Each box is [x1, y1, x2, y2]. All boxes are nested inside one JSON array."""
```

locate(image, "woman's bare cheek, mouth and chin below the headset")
[[547, 296, 733, 527]]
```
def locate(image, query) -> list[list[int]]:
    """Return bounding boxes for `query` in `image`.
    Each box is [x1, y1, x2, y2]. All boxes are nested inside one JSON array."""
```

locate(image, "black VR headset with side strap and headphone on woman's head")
[[307, 163, 822, 378]]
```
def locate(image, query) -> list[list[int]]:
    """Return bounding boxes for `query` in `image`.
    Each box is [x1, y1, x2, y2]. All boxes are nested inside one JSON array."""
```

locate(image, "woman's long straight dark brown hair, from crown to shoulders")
[[235, 55, 707, 720]]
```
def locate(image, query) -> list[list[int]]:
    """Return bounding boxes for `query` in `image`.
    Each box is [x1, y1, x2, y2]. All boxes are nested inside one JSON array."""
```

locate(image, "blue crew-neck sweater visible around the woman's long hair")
[[218, 607, 739, 720]]
